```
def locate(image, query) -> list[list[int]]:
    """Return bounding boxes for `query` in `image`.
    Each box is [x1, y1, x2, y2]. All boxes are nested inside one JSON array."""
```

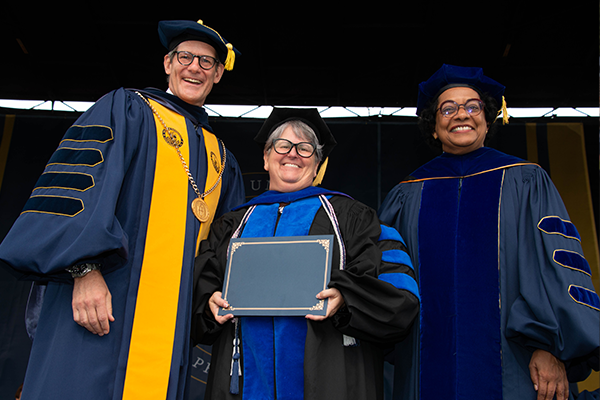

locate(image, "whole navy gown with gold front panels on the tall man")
[[0, 89, 244, 400]]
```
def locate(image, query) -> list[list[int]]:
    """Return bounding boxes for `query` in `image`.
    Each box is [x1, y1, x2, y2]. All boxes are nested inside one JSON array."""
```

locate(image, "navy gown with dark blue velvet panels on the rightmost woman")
[[379, 148, 599, 400]]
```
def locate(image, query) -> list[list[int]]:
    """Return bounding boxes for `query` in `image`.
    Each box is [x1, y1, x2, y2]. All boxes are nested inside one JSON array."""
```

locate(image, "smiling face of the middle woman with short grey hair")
[[263, 126, 318, 193]]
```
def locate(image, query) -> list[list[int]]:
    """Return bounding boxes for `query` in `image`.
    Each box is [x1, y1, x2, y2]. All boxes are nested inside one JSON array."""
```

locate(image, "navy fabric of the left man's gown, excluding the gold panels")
[[0, 89, 244, 400]]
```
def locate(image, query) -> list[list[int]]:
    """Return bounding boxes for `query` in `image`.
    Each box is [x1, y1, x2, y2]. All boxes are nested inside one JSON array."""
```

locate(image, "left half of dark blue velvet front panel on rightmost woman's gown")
[[419, 179, 458, 400]]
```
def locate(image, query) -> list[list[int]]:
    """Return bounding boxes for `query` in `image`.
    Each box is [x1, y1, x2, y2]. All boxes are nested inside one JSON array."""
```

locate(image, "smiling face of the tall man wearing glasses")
[[164, 40, 224, 107]]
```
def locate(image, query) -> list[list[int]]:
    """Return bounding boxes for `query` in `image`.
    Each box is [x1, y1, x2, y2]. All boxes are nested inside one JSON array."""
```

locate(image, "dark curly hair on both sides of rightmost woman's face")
[[418, 92, 499, 149]]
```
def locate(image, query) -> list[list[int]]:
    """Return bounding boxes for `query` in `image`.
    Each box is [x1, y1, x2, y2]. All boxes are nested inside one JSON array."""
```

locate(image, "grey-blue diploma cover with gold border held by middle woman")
[[219, 235, 333, 316]]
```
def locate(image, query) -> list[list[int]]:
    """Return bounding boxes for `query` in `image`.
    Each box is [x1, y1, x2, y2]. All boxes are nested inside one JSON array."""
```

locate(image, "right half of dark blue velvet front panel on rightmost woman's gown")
[[457, 170, 504, 400]]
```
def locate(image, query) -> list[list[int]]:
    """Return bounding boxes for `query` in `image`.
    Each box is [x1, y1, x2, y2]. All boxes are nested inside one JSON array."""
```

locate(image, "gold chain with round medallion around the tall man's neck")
[[135, 92, 227, 222]]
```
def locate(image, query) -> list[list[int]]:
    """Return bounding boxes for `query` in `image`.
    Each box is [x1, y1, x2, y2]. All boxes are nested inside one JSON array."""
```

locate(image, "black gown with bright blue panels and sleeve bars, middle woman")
[[192, 187, 419, 400]]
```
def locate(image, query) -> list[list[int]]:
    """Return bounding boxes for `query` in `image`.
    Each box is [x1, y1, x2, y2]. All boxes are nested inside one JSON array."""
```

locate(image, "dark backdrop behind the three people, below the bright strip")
[[0, 110, 599, 399]]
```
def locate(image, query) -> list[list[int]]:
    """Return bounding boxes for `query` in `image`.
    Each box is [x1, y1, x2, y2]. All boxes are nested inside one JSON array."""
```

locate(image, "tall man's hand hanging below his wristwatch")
[[72, 270, 115, 336]]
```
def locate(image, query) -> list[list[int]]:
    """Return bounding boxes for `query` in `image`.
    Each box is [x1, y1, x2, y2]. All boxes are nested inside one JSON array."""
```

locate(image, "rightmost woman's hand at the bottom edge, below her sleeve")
[[529, 350, 569, 400]]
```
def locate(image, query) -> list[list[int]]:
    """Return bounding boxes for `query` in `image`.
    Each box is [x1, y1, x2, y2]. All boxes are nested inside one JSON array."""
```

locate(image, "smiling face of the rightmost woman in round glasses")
[[433, 87, 488, 155]]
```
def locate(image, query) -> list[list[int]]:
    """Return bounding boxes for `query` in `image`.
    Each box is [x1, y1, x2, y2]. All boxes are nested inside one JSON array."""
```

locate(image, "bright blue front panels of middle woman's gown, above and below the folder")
[[241, 197, 321, 399]]
